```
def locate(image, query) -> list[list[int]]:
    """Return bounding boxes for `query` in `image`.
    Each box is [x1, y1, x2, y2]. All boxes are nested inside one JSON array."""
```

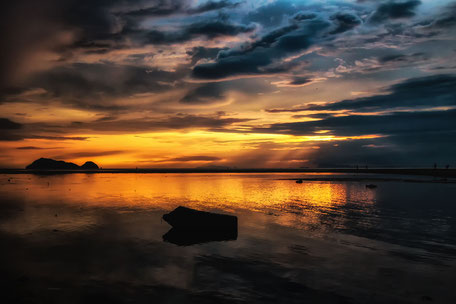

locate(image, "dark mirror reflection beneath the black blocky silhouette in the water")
[[163, 227, 237, 246]]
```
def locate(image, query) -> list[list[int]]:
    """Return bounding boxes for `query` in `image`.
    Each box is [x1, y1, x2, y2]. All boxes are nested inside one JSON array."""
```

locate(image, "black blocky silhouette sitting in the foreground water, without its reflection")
[[163, 206, 237, 231]]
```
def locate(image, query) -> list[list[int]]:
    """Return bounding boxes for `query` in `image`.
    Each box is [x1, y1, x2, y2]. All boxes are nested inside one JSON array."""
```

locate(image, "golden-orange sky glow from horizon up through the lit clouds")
[[0, 73, 388, 168]]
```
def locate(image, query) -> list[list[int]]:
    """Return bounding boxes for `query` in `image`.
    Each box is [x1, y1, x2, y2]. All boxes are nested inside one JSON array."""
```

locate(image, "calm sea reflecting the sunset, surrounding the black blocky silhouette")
[[0, 174, 456, 303]]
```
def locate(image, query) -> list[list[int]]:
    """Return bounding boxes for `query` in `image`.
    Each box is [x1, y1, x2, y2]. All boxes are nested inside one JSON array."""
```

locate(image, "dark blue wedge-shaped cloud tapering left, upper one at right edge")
[[300, 75, 456, 112]]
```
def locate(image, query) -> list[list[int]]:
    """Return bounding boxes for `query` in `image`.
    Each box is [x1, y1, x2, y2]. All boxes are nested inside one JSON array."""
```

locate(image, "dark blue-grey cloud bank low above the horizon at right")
[[256, 106, 456, 167]]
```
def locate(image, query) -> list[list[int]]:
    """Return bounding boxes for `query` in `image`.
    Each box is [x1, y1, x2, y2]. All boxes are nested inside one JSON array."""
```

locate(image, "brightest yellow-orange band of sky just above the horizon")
[[0, 130, 381, 168]]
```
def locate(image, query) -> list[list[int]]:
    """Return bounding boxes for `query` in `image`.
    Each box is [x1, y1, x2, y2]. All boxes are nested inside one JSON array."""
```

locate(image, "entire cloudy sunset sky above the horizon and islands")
[[0, 0, 456, 168]]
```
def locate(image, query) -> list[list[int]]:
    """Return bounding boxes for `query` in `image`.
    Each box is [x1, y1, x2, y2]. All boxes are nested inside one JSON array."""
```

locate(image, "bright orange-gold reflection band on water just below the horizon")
[[0, 173, 374, 211]]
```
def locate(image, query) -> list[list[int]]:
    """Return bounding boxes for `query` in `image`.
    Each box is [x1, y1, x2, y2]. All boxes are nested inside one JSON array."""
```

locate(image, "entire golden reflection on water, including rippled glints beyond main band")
[[0, 173, 375, 230]]
